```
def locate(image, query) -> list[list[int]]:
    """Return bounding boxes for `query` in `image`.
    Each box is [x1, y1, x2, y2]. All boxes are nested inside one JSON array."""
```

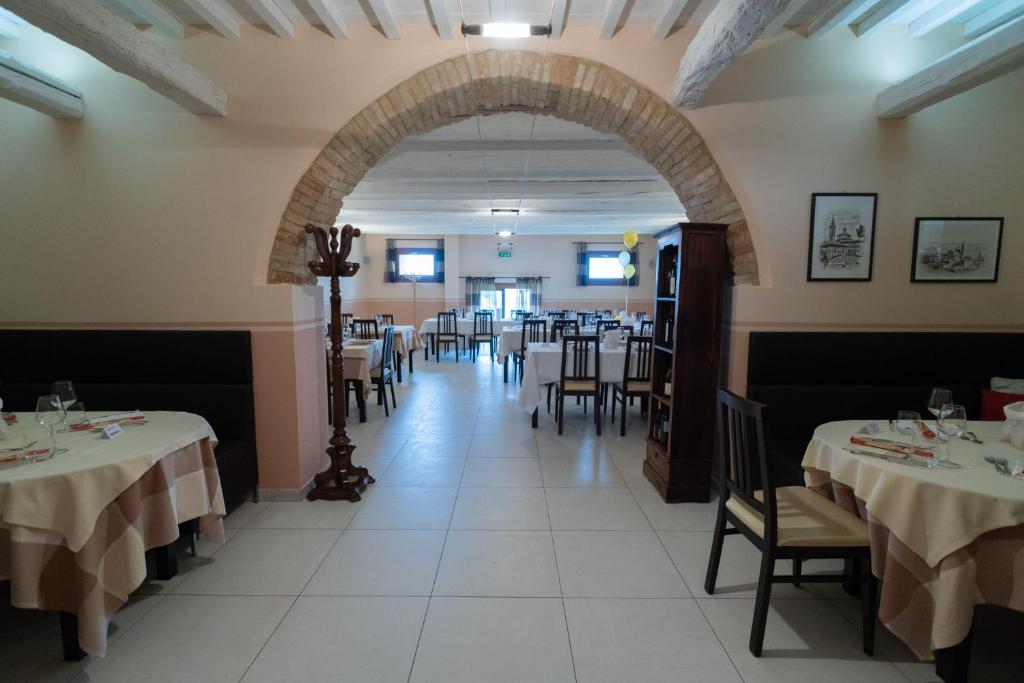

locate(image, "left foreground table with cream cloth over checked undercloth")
[[0, 411, 225, 659]]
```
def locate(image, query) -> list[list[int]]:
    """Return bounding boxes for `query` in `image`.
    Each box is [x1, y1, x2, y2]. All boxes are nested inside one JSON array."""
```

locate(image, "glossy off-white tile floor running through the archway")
[[0, 356, 978, 683]]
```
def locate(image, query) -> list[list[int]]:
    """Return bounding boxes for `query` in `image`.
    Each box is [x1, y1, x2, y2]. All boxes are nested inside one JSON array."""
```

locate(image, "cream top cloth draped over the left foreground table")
[[0, 411, 223, 552]]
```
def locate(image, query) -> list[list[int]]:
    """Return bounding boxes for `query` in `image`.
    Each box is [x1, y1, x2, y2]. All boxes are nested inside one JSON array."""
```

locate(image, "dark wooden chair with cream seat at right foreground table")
[[705, 389, 878, 656]]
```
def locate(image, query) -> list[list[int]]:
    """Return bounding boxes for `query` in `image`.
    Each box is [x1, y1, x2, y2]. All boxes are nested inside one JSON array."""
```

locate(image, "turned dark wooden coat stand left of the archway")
[[305, 223, 376, 502]]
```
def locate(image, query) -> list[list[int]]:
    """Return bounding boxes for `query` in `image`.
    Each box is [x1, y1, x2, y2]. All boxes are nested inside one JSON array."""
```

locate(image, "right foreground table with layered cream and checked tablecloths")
[[802, 420, 1024, 680]]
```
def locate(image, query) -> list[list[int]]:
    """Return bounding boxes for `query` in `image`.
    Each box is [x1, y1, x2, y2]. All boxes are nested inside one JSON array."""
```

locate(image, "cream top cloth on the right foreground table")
[[802, 420, 1024, 567]]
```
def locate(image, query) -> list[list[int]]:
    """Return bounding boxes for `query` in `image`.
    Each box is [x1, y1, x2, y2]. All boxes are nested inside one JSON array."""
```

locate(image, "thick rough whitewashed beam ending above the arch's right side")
[[672, 0, 792, 109]]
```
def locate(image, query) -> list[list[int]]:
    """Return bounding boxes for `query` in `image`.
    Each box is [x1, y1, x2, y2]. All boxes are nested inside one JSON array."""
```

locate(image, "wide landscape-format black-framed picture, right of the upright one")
[[910, 218, 1002, 283]]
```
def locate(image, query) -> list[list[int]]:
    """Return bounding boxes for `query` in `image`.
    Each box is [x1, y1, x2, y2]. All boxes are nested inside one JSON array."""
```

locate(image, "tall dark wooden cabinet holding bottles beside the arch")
[[643, 223, 728, 503]]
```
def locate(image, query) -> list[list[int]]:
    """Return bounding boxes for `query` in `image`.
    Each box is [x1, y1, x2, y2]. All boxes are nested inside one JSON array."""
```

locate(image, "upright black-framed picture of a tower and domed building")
[[807, 193, 879, 282]]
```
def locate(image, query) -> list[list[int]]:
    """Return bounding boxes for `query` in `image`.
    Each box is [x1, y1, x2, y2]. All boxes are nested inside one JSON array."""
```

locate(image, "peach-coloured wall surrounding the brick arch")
[[0, 22, 1024, 488]]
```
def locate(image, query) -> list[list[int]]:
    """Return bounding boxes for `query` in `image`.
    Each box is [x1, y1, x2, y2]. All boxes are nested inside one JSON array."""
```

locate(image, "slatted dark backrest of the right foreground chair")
[[716, 388, 777, 547]]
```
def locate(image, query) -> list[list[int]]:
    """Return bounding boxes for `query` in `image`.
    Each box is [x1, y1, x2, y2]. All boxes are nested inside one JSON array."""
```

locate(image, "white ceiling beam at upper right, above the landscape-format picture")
[[879, 16, 1024, 119]]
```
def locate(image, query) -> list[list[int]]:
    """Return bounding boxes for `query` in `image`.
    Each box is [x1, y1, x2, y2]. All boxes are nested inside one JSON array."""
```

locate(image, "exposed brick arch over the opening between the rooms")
[[267, 50, 758, 285]]
